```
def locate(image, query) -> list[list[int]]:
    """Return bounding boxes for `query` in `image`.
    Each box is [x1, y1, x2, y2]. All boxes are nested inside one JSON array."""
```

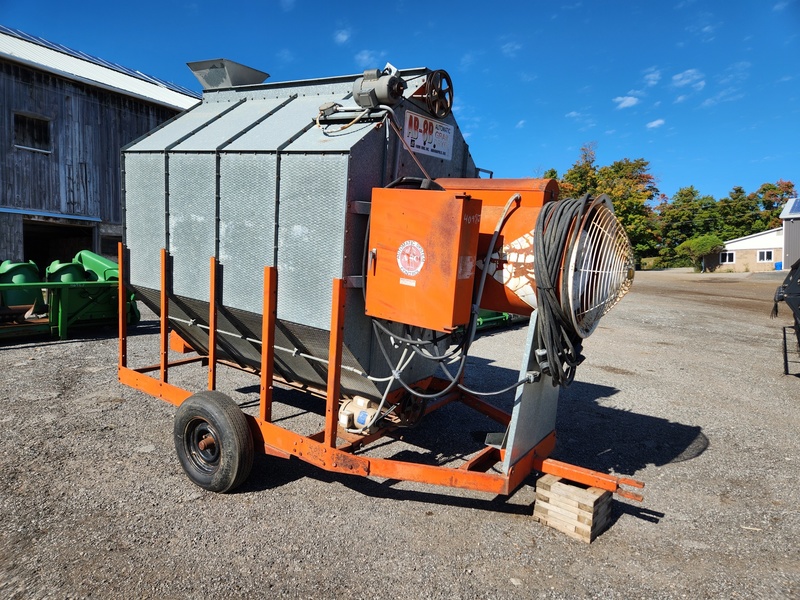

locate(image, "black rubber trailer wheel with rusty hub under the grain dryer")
[[173, 391, 253, 492]]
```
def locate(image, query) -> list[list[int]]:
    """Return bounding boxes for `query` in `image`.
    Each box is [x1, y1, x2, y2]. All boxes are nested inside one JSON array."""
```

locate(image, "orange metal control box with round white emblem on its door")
[[366, 188, 481, 332]]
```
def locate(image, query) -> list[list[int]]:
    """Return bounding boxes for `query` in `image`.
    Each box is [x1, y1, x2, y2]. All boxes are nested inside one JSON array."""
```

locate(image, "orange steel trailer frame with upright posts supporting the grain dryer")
[[118, 244, 644, 501]]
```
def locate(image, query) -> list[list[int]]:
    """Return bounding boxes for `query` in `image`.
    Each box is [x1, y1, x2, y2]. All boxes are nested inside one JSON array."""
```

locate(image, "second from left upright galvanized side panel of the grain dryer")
[[169, 153, 217, 302]]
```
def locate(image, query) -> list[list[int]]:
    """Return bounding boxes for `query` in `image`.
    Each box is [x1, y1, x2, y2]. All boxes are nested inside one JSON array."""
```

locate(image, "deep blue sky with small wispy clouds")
[[0, 0, 800, 199]]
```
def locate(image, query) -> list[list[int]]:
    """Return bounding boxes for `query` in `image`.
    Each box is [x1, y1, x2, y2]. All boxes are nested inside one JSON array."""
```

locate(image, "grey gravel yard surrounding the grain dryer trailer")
[[0, 271, 800, 599]]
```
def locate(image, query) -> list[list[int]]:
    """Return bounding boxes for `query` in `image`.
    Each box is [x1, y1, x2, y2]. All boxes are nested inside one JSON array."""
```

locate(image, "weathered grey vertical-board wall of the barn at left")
[[0, 61, 179, 258]]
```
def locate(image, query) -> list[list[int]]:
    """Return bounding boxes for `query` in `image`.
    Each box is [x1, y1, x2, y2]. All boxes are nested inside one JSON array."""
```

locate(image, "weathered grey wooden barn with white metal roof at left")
[[0, 26, 199, 271]]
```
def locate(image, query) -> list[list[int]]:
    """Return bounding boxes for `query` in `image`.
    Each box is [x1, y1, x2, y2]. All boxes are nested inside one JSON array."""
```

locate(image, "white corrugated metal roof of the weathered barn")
[[0, 25, 200, 110]]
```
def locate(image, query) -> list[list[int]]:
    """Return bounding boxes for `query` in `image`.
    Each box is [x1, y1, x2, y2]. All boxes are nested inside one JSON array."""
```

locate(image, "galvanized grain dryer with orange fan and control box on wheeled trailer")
[[119, 60, 641, 497]]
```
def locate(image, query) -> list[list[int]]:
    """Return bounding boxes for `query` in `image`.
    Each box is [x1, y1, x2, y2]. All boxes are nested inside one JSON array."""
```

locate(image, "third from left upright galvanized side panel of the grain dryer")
[[219, 153, 277, 314]]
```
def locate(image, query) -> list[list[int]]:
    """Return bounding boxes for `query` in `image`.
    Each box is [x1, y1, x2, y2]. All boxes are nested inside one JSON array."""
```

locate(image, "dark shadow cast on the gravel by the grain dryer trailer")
[[233, 369, 709, 523]]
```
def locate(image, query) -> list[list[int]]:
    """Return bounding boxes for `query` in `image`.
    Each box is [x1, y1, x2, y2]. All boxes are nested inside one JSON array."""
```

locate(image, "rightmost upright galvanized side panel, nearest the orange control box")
[[278, 154, 349, 329]]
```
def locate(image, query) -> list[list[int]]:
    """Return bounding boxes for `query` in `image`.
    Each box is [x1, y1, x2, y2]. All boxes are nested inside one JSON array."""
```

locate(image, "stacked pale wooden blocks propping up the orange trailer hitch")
[[533, 475, 611, 544]]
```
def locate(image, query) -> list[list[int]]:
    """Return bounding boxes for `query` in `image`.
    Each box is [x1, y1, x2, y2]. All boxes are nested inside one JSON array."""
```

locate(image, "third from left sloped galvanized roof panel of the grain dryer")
[[225, 94, 342, 152]]
